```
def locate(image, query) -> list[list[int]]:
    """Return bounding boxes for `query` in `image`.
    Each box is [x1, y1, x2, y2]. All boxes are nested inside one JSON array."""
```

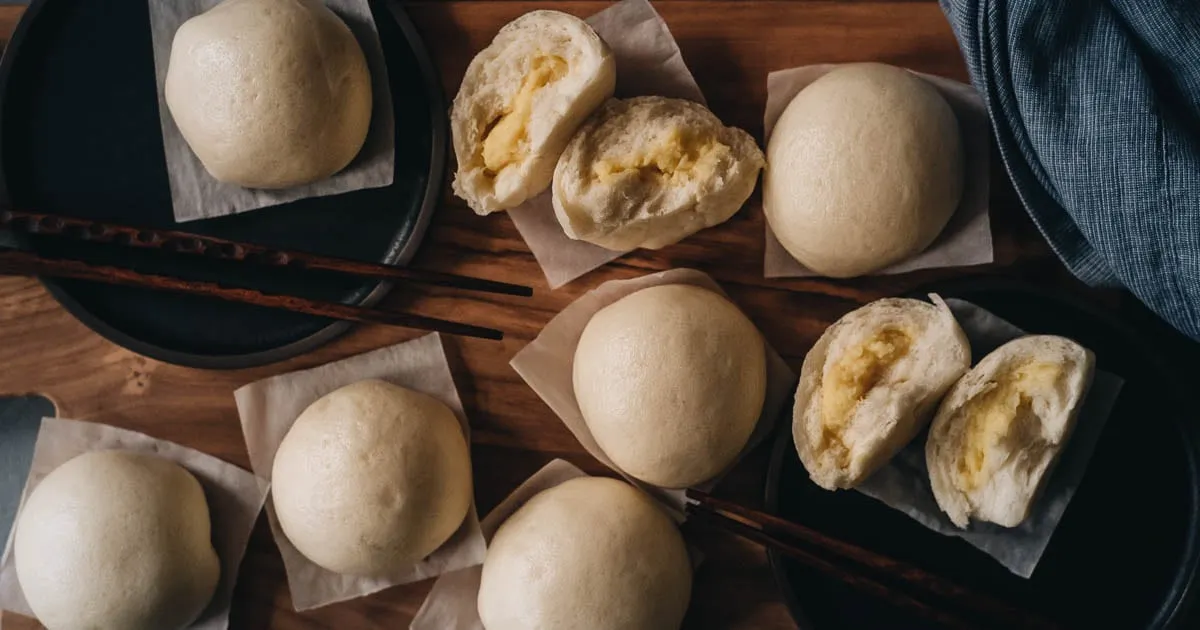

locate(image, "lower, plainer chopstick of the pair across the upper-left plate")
[[0, 250, 504, 340]]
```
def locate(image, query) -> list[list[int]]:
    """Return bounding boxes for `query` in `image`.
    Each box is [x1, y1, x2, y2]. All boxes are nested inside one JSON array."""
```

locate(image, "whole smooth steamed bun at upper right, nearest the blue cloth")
[[763, 64, 964, 277]]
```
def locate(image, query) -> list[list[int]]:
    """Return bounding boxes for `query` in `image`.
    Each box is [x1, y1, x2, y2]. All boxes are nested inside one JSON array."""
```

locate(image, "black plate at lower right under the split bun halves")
[[767, 283, 1200, 630]]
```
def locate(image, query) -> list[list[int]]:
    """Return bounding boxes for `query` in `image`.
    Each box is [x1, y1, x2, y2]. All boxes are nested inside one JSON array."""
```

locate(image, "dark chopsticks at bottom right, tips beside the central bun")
[[684, 490, 1058, 630]]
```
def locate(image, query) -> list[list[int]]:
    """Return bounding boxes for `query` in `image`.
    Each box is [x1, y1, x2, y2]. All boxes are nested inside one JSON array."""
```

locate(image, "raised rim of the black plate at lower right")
[[763, 277, 1200, 630]]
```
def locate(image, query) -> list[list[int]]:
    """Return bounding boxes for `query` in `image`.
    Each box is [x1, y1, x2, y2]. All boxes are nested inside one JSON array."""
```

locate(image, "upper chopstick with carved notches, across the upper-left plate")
[[0, 210, 533, 298]]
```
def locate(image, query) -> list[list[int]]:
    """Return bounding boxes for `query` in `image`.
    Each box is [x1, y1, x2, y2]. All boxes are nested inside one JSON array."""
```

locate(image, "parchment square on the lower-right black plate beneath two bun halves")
[[857, 299, 1124, 577]]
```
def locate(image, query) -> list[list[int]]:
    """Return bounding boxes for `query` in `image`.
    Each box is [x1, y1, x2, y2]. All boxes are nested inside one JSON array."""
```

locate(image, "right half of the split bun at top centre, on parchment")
[[553, 96, 764, 251]]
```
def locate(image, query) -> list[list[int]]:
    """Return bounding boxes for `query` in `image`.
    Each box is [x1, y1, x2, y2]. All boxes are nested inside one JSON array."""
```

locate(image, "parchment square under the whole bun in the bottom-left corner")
[[0, 418, 268, 630]]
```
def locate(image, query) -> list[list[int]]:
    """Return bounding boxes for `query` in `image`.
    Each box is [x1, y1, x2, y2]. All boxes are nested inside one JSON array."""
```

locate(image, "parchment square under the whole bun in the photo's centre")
[[510, 269, 797, 518]]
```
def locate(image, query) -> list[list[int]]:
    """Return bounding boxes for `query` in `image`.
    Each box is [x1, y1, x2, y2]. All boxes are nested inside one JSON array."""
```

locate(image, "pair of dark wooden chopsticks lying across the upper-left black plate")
[[0, 210, 533, 340]]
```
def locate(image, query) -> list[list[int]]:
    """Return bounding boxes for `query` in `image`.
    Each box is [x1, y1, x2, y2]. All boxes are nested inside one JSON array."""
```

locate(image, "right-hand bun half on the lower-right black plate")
[[925, 335, 1094, 528]]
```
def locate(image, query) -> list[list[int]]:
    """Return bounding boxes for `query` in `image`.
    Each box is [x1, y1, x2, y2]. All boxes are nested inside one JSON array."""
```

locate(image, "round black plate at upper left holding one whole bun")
[[0, 0, 446, 367]]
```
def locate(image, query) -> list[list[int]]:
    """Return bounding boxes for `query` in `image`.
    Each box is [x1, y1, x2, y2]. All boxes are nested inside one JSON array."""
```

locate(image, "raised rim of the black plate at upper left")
[[0, 0, 449, 370]]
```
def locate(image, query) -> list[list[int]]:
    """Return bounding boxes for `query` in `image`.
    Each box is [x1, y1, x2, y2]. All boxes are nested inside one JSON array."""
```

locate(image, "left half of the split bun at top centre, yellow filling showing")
[[450, 11, 617, 215]]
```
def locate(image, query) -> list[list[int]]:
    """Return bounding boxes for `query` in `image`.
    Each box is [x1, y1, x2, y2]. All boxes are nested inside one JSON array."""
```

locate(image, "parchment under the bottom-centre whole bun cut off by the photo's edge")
[[408, 460, 587, 630]]
